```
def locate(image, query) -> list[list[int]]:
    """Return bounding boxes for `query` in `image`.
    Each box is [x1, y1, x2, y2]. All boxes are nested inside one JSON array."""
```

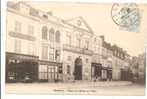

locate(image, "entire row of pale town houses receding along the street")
[[6, 2, 130, 82]]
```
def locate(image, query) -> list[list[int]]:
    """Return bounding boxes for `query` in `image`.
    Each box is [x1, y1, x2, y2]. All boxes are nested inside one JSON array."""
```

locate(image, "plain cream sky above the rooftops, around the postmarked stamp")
[[27, 2, 147, 56]]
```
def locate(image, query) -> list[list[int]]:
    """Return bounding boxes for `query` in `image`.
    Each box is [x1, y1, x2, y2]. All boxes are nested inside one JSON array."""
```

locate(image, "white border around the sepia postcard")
[[1, 0, 147, 99]]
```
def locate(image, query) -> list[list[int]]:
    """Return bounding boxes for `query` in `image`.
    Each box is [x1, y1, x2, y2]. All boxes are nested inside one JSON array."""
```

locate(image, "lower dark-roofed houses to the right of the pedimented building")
[[91, 36, 130, 80]]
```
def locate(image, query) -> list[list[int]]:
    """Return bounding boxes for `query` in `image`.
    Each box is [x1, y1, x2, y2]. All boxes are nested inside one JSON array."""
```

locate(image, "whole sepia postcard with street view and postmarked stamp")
[[5, 1, 147, 96]]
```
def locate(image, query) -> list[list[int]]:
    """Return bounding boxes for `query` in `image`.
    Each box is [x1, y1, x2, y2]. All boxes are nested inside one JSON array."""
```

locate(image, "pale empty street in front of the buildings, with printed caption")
[[6, 81, 145, 96]]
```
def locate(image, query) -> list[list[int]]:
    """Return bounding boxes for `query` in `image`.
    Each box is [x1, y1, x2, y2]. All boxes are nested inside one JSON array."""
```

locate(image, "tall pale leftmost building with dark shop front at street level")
[[6, 3, 40, 81]]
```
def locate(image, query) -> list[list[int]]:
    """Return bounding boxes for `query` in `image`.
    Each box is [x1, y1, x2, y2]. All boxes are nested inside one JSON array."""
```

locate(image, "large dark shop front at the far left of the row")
[[6, 53, 38, 82]]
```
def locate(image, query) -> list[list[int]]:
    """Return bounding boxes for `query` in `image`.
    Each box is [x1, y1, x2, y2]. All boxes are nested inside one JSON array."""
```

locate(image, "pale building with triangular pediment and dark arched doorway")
[[62, 17, 93, 81]]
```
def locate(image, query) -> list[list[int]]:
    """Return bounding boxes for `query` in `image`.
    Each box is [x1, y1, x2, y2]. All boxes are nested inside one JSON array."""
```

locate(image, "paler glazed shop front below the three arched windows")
[[38, 61, 63, 82]]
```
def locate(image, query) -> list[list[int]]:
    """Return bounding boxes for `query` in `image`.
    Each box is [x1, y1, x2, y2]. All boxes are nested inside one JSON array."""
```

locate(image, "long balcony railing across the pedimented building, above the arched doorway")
[[63, 44, 93, 55]]
